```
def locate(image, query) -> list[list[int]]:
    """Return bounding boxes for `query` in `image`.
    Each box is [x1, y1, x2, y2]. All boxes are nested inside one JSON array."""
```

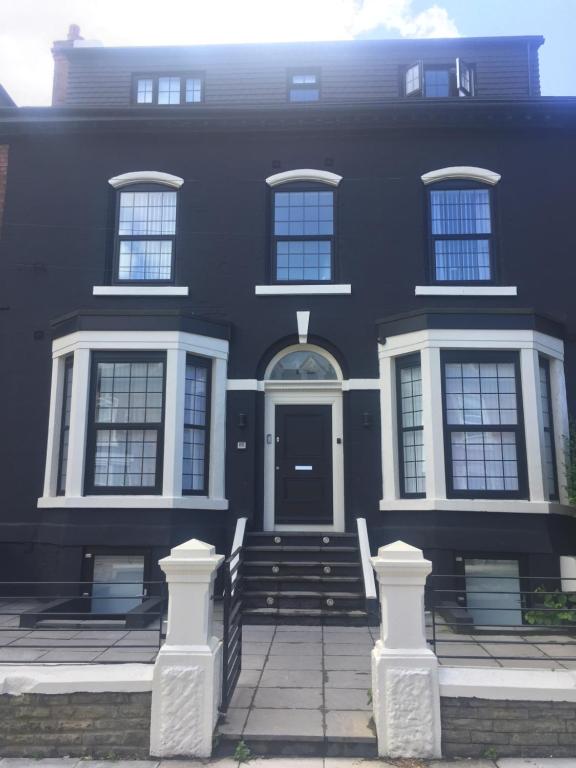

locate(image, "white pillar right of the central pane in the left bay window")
[[162, 349, 186, 498]]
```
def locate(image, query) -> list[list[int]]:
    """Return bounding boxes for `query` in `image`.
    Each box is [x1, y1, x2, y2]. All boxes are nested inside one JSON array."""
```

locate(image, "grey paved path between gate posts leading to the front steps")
[[219, 626, 377, 744]]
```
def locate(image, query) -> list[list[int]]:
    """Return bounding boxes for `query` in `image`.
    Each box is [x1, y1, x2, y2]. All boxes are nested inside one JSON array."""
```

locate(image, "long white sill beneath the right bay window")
[[380, 499, 576, 516]]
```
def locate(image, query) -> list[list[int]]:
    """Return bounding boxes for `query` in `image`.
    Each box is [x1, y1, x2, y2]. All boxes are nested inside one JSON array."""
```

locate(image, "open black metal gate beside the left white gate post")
[[220, 546, 244, 714]]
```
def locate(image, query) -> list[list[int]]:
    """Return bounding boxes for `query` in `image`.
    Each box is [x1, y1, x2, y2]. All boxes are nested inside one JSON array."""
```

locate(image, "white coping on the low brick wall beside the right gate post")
[[438, 666, 576, 702]]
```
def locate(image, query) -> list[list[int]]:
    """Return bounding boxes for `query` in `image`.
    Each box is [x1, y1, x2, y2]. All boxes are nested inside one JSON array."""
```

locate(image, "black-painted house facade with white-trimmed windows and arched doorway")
[[0, 35, 576, 616]]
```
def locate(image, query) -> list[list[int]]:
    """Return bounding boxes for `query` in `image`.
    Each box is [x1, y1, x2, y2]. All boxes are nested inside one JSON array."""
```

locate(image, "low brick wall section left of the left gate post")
[[0, 693, 152, 758]]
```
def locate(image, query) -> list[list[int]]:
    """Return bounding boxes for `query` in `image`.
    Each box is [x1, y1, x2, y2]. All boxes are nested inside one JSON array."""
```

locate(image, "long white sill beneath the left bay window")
[[38, 494, 228, 510]]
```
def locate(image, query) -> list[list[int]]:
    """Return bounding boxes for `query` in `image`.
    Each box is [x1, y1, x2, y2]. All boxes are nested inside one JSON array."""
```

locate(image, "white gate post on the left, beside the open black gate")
[[150, 539, 224, 757]]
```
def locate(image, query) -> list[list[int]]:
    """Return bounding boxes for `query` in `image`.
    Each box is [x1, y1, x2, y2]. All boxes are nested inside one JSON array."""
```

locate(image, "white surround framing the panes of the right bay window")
[[378, 329, 574, 514]]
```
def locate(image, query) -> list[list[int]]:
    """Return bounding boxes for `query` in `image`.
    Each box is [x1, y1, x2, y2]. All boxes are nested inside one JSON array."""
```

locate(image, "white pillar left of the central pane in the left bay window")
[[66, 347, 90, 496]]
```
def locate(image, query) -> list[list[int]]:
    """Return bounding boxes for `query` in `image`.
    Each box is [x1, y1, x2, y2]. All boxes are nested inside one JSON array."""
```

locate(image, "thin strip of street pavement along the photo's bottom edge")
[[0, 757, 576, 768]]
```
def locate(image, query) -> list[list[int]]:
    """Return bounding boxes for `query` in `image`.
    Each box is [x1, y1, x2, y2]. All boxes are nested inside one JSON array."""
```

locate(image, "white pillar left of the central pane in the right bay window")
[[420, 347, 446, 499]]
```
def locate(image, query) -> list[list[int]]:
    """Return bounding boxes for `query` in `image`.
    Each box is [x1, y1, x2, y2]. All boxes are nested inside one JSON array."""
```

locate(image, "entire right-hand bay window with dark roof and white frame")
[[378, 310, 568, 513]]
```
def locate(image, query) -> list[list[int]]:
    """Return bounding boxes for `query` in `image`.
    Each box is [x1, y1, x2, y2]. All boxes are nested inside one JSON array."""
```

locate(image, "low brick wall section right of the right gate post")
[[441, 698, 576, 757]]
